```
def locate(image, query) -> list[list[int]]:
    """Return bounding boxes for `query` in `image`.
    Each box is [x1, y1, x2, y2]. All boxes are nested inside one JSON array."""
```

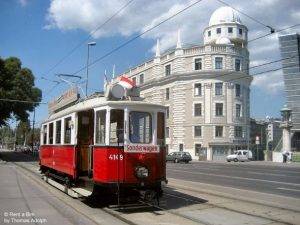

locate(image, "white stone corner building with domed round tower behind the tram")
[[116, 7, 252, 160]]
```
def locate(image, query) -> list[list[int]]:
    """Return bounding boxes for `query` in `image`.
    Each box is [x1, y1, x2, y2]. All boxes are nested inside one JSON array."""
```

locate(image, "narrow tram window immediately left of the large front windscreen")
[[109, 109, 124, 145]]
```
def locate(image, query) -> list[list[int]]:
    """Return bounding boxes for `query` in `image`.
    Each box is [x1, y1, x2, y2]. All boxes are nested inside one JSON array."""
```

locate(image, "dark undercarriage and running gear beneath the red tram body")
[[40, 166, 167, 206]]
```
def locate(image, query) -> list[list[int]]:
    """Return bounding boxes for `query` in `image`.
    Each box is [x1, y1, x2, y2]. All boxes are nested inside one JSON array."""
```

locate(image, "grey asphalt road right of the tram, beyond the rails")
[[167, 162, 300, 198]]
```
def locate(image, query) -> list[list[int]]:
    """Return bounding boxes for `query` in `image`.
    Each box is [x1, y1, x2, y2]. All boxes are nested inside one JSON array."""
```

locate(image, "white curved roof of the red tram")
[[43, 96, 166, 123]]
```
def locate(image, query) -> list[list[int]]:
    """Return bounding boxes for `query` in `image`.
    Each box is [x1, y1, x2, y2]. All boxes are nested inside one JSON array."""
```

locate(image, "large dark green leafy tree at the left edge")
[[0, 57, 42, 127]]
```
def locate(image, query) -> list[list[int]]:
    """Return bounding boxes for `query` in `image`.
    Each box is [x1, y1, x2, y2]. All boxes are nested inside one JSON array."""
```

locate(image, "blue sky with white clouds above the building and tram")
[[0, 0, 300, 124]]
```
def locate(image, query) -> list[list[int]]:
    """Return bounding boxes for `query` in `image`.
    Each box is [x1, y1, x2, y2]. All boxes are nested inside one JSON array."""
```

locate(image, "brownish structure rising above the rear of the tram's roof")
[[48, 87, 79, 114]]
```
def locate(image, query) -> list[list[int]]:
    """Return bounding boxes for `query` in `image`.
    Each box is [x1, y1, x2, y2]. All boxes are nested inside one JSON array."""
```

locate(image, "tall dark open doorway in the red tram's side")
[[77, 110, 94, 176]]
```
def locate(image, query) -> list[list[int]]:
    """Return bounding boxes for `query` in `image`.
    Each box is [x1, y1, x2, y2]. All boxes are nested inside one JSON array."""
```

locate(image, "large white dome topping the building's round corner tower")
[[209, 6, 242, 26]]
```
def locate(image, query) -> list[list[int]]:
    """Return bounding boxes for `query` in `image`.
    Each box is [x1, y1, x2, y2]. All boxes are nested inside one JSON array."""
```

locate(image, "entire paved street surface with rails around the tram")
[[0, 151, 300, 225]]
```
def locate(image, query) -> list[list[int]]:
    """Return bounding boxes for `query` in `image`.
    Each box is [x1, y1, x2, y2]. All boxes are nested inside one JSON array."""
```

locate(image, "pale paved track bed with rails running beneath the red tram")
[[0, 150, 299, 225]]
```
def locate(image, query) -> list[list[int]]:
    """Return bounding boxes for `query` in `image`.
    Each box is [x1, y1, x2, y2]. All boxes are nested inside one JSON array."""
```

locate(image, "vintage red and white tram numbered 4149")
[[40, 84, 166, 200]]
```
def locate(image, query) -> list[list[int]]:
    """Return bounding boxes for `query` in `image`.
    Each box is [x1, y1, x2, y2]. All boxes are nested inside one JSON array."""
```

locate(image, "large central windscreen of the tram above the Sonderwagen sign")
[[129, 112, 152, 144]]
